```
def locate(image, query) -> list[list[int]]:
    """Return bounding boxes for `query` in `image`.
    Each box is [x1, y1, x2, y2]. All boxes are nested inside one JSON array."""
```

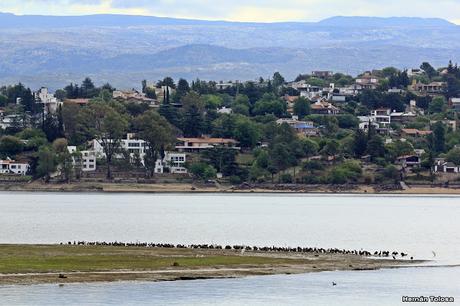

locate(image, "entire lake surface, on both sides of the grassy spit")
[[0, 193, 460, 305]]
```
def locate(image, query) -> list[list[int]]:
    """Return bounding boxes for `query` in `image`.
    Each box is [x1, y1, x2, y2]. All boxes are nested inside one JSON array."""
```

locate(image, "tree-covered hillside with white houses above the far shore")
[[0, 63, 460, 188]]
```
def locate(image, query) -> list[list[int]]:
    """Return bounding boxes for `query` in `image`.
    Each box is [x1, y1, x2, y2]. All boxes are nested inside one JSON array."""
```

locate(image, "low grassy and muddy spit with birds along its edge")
[[0, 244, 428, 286]]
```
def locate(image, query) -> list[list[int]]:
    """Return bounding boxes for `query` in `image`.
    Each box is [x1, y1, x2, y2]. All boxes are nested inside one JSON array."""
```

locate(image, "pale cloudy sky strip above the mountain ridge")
[[0, 0, 460, 24]]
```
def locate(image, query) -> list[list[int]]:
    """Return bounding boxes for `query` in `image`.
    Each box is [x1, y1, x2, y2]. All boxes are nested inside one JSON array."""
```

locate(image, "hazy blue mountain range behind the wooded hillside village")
[[0, 13, 460, 89]]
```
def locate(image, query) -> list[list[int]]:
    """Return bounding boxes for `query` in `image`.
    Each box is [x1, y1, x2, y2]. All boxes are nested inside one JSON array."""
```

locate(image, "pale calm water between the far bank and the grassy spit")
[[0, 193, 460, 263]]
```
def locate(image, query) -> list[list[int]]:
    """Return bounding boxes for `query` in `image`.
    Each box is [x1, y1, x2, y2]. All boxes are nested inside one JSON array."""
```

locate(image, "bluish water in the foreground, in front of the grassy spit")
[[0, 268, 460, 306]]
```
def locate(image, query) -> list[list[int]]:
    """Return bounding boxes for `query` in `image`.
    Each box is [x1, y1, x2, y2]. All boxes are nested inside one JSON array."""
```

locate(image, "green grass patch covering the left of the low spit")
[[0, 245, 305, 273]]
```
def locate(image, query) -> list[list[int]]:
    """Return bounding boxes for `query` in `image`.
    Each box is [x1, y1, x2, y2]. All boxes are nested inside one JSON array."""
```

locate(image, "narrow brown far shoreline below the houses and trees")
[[0, 182, 460, 196]]
